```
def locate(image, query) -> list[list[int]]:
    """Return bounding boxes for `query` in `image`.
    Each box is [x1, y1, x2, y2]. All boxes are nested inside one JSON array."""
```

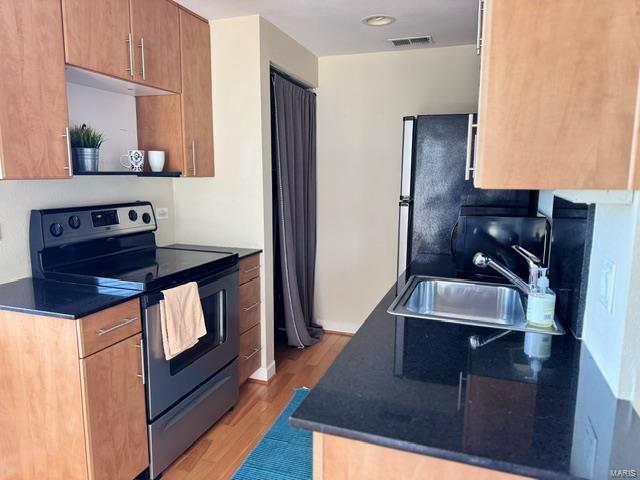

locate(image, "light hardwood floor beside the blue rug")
[[162, 333, 350, 480]]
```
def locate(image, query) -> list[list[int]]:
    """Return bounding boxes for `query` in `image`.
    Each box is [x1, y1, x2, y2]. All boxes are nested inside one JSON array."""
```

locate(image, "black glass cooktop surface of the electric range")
[[46, 247, 238, 291]]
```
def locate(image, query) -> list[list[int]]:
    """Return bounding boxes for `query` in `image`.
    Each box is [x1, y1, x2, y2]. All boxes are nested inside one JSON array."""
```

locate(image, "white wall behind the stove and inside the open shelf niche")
[[0, 84, 174, 283]]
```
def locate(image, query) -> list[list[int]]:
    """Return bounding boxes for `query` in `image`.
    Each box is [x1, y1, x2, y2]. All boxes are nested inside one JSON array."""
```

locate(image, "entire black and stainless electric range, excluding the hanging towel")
[[30, 202, 240, 478]]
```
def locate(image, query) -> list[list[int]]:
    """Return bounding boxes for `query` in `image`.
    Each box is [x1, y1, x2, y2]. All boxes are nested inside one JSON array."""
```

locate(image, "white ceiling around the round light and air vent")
[[178, 0, 478, 56]]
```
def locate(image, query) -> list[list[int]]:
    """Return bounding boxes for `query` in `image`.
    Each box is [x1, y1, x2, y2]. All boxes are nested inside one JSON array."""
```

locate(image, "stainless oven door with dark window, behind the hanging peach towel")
[[142, 265, 240, 421]]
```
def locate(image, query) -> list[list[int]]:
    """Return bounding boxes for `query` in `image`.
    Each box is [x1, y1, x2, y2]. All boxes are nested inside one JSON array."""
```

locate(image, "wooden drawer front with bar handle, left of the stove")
[[78, 299, 142, 358]]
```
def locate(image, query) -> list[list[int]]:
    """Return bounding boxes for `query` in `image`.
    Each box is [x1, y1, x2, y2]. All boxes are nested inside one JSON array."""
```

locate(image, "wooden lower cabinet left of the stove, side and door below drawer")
[[0, 304, 149, 480]]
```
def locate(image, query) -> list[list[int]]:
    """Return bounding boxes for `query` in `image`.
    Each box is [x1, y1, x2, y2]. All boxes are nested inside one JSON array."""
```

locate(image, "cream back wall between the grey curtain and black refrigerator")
[[316, 46, 480, 332]]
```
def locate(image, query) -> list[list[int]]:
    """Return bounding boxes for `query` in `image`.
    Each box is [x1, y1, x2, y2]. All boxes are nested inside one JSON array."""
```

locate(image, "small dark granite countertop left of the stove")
[[0, 277, 141, 320]]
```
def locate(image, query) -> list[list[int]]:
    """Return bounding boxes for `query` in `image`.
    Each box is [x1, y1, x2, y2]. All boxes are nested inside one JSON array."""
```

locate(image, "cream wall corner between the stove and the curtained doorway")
[[174, 15, 317, 380]]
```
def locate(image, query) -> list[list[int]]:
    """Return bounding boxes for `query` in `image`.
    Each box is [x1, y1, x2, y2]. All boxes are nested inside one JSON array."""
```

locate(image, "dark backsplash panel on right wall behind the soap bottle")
[[549, 197, 596, 338]]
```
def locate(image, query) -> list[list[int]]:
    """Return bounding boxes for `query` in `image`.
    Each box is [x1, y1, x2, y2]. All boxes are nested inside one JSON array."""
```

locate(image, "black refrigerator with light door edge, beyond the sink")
[[398, 113, 538, 276]]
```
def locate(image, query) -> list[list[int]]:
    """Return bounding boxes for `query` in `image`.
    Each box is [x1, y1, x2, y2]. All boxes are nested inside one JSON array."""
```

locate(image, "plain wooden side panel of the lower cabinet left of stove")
[[0, 310, 87, 480]]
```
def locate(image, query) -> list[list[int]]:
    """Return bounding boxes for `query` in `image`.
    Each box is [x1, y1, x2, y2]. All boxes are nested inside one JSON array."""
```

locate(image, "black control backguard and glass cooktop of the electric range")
[[30, 202, 238, 291]]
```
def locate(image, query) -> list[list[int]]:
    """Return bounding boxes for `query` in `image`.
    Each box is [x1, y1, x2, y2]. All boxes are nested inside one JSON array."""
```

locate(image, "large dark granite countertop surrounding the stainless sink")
[[290, 256, 640, 479]]
